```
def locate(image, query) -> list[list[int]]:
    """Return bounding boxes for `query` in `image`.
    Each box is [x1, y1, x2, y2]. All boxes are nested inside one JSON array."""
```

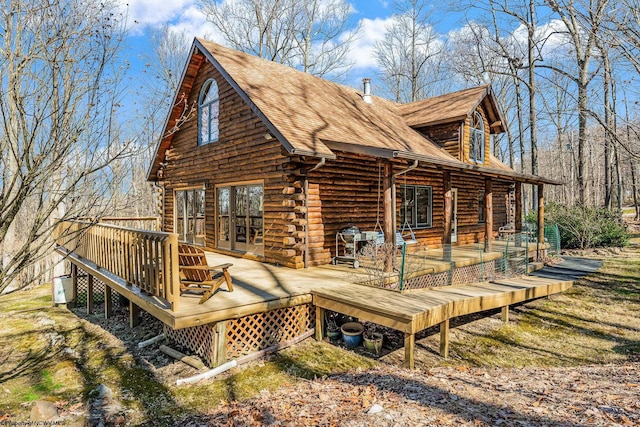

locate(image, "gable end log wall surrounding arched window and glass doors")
[[163, 61, 303, 267]]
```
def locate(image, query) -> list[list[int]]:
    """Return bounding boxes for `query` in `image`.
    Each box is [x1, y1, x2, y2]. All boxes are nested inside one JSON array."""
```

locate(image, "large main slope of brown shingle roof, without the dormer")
[[197, 39, 454, 160]]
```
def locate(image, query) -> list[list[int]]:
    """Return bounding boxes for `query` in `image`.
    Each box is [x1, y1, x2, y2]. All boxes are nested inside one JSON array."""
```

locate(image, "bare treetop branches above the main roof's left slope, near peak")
[[200, 0, 357, 77]]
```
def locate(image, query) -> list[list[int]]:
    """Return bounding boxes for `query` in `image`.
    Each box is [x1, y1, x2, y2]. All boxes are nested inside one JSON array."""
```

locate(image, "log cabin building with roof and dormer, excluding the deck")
[[148, 38, 556, 268]]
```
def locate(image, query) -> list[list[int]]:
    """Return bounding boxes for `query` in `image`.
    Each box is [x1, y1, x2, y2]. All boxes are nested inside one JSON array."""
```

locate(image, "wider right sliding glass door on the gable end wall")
[[217, 184, 264, 255]]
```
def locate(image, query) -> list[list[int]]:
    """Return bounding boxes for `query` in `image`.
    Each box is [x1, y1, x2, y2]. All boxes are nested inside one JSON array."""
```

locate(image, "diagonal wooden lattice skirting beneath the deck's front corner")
[[164, 304, 315, 367]]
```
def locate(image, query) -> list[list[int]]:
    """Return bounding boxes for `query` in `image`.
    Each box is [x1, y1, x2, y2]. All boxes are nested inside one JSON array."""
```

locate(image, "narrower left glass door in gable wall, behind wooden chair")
[[175, 189, 204, 245]]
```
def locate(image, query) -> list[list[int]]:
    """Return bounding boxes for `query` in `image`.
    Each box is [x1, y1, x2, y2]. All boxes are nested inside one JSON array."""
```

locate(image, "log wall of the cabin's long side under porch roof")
[[308, 153, 510, 265]]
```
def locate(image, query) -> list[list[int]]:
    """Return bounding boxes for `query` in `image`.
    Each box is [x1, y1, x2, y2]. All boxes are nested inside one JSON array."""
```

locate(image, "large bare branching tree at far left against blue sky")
[[0, 0, 128, 292]]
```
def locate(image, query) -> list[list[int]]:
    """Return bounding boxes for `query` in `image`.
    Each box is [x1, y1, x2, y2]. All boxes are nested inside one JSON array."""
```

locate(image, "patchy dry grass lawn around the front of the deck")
[[0, 239, 640, 426]]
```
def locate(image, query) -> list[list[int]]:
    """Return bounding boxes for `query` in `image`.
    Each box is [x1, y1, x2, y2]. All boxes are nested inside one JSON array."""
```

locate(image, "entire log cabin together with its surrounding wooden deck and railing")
[[55, 39, 571, 367]]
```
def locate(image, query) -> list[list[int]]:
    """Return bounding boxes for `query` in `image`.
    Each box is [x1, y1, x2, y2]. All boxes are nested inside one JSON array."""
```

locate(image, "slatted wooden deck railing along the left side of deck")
[[55, 221, 180, 311]]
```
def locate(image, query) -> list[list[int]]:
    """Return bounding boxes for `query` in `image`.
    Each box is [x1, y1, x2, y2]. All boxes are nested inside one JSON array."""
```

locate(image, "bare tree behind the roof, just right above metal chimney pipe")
[[375, 0, 444, 102]]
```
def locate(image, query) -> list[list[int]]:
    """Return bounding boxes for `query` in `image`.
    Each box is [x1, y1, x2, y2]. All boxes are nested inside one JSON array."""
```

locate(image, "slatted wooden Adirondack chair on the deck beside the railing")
[[178, 244, 233, 304]]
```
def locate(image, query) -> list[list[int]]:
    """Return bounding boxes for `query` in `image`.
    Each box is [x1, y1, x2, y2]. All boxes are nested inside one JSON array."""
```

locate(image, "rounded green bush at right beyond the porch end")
[[545, 203, 629, 249]]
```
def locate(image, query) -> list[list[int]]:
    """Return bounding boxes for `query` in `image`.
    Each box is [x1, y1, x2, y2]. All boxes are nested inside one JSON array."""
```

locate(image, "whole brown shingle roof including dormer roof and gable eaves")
[[148, 38, 552, 182]]
